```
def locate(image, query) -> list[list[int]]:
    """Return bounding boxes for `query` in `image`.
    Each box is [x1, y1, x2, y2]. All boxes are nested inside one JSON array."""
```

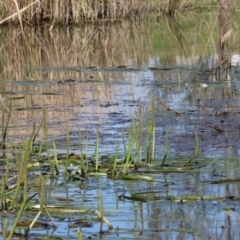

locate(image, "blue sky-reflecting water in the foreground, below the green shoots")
[[20, 163, 240, 239]]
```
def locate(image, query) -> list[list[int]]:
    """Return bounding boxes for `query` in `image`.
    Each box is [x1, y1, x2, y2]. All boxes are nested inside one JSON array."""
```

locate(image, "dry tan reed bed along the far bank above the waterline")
[[0, 0, 218, 24]]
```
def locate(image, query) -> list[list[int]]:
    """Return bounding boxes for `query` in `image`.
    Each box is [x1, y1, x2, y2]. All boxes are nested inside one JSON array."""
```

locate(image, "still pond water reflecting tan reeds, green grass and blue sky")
[[0, 7, 240, 239]]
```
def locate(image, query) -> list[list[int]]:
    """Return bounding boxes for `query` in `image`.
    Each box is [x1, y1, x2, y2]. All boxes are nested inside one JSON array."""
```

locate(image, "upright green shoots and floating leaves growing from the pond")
[[1, 92, 219, 239]]
